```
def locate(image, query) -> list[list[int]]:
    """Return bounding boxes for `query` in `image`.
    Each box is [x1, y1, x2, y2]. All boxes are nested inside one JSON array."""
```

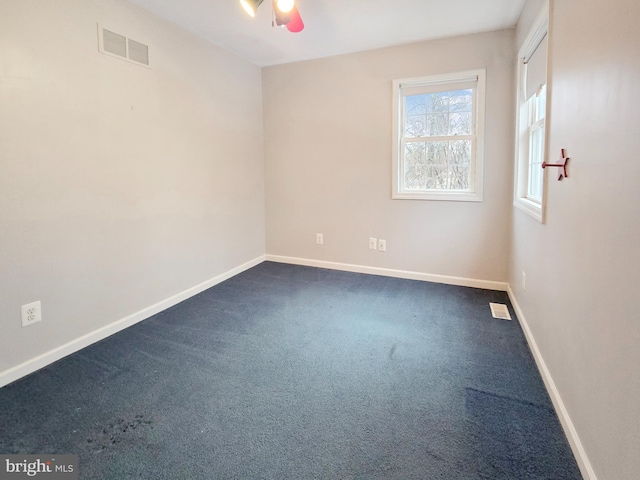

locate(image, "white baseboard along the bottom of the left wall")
[[0, 255, 265, 388]]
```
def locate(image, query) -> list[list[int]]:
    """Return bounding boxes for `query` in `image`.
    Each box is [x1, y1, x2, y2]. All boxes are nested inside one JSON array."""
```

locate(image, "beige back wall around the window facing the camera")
[[263, 30, 515, 282]]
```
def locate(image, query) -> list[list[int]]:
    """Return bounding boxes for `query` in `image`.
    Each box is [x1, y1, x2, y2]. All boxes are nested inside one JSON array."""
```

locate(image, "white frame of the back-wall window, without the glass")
[[392, 69, 486, 202]]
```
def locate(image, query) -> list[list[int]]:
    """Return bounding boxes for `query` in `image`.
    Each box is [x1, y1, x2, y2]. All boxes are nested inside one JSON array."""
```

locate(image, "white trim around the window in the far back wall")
[[391, 68, 487, 202]]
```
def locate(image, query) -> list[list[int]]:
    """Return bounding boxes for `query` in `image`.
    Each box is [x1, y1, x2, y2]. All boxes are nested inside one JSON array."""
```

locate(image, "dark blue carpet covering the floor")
[[0, 262, 581, 480]]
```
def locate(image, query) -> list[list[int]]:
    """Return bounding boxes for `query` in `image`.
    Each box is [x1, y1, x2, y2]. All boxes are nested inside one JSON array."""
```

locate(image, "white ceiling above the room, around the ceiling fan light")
[[131, 0, 525, 66]]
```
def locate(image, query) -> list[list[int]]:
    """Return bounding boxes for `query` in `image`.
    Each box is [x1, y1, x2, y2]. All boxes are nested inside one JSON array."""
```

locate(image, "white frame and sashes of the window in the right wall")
[[513, 1, 551, 223]]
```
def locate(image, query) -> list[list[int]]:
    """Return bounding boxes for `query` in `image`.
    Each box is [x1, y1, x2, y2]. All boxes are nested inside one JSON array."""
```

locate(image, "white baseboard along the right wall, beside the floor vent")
[[507, 285, 598, 480]]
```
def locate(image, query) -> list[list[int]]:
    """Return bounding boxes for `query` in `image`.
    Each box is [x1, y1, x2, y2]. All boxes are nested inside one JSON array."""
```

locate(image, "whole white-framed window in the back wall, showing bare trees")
[[393, 70, 485, 201]]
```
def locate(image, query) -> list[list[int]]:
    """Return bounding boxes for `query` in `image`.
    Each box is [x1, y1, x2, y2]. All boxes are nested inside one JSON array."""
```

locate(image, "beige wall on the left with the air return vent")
[[0, 0, 264, 373]]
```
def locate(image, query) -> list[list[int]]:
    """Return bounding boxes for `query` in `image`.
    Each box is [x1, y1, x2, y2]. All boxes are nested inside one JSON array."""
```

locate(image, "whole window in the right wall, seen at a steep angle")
[[514, 3, 549, 222]]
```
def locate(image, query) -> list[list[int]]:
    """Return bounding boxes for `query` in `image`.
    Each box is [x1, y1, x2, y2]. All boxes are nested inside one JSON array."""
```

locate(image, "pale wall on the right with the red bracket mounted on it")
[[510, 0, 640, 480]]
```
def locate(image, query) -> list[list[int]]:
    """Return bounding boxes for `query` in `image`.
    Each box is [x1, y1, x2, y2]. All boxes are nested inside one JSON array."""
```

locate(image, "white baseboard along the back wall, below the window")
[[266, 255, 507, 292]]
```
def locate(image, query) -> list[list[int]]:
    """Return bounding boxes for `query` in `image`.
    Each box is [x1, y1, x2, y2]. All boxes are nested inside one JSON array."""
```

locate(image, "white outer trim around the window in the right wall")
[[513, 0, 551, 223]]
